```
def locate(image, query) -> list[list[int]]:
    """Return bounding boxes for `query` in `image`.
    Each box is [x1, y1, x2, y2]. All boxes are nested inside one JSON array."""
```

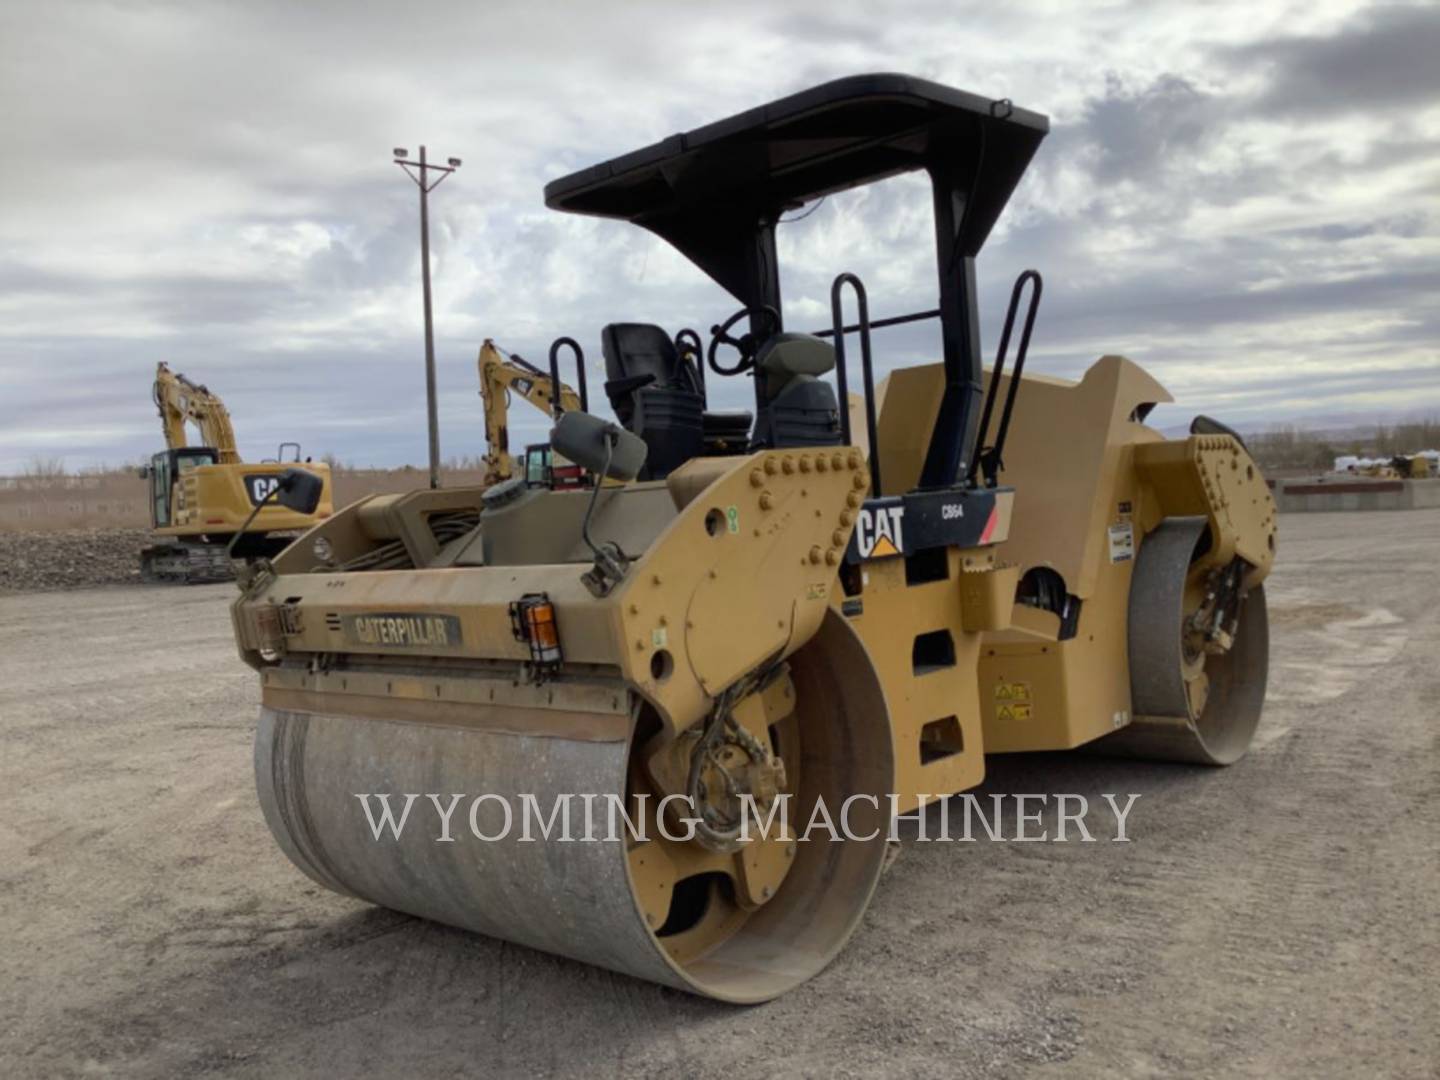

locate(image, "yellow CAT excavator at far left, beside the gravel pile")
[[140, 361, 334, 583]]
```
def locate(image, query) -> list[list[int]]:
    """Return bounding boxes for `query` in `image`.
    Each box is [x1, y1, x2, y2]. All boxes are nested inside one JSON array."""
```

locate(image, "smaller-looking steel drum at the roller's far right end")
[[1093, 517, 1270, 765]]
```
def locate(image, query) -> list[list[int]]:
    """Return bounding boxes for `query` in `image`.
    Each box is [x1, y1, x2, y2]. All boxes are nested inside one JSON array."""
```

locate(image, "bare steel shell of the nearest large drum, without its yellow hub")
[[255, 613, 893, 1004]]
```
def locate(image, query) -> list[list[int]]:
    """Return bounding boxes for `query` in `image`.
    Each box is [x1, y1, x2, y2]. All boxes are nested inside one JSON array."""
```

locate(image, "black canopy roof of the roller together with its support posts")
[[544, 75, 1050, 488]]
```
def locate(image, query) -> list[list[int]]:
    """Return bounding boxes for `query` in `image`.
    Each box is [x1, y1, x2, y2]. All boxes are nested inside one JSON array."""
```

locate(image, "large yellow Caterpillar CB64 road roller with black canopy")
[[232, 75, 1274, 1002]]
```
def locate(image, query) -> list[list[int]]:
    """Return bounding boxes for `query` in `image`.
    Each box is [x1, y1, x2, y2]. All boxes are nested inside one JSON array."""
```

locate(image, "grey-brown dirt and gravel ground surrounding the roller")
[[0, 511, 1440, 1080]]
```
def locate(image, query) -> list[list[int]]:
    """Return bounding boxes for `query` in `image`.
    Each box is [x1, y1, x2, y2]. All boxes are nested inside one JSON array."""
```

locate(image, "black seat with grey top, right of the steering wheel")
[[750, 334, 840, 449]]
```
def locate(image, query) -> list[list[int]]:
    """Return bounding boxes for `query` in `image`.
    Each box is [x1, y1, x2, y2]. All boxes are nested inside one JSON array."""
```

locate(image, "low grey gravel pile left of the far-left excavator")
[[0, 528, 150, 592]]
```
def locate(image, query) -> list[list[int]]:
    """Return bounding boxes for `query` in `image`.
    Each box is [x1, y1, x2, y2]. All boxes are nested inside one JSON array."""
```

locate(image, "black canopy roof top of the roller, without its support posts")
[[544, 75, 1050, 291]]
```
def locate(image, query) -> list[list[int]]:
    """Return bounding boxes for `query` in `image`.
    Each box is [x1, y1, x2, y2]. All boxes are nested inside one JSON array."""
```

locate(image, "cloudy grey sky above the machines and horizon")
[[0, 0, 1440, 472]]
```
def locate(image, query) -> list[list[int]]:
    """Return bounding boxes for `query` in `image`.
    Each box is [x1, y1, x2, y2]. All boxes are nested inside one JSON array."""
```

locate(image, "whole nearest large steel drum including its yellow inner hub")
[[255, 615, 893, 1004]]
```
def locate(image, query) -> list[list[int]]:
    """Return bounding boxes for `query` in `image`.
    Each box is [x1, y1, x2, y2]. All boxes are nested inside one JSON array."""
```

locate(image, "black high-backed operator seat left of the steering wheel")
[[600, 323, 704, 480]]
